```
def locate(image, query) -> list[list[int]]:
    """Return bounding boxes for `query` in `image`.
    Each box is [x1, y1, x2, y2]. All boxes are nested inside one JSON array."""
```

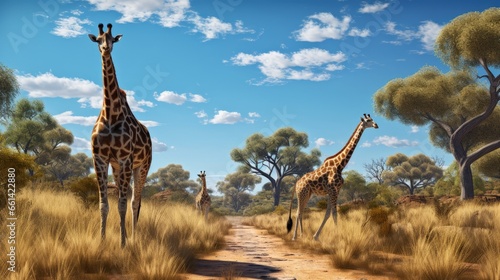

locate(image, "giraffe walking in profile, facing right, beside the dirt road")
[[286, 114, 378, 240]]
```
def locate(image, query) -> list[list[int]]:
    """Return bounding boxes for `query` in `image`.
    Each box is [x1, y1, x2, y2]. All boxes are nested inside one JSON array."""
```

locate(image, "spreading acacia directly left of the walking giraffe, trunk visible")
[[231, 127, 321, 206]]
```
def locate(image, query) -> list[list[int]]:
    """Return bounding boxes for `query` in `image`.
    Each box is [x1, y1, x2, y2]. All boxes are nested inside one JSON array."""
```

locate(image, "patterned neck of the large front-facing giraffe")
[[101, 55, 127, 120]]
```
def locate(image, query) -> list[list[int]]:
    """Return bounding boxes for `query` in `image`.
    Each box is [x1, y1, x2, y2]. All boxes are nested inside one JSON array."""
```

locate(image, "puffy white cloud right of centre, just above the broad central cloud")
[[294, 13, 351, 42]]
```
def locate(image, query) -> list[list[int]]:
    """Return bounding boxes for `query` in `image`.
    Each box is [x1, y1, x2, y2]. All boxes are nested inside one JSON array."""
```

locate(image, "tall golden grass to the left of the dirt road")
[[0, 188, 230, 279]]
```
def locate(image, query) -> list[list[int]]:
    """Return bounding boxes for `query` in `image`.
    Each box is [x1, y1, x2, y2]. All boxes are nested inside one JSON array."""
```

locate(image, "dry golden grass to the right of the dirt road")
[[246, 202, 500, 280]]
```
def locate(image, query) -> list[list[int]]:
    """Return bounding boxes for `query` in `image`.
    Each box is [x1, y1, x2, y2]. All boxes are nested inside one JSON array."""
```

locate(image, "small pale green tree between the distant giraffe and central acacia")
[[217, 168, 261, 212]]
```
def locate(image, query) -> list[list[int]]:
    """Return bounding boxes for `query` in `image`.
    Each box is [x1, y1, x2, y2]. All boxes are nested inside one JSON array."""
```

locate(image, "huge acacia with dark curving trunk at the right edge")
[[374, 8, 500, 199]]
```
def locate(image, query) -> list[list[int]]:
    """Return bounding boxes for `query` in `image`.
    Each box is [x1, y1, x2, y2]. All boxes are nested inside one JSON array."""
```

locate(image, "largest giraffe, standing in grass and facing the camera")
[[89, 23, 152, 247]]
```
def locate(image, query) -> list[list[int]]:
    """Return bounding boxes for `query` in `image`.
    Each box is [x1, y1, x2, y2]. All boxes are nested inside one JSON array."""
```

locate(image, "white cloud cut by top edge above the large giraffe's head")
[[87, 0, 190, 27]]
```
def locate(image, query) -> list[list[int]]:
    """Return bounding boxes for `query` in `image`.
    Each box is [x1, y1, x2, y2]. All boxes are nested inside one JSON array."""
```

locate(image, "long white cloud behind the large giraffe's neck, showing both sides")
[[17, 73, 154, 112]]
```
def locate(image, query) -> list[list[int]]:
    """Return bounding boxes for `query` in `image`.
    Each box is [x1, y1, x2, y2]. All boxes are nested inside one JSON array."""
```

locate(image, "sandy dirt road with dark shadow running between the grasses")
[[183, 217, 389, 280]]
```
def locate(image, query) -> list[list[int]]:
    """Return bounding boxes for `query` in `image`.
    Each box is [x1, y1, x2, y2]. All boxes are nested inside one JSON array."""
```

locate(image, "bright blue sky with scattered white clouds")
[[0, 0, 492, 190]]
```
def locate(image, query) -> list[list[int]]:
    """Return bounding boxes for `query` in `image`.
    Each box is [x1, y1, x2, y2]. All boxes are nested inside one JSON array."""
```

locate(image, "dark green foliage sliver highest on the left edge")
[[0, 64, 19, 123]]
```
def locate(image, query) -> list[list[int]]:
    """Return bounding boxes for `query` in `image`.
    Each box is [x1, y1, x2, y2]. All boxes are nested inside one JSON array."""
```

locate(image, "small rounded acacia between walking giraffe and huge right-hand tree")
[[382, 153, 443, 195]]
